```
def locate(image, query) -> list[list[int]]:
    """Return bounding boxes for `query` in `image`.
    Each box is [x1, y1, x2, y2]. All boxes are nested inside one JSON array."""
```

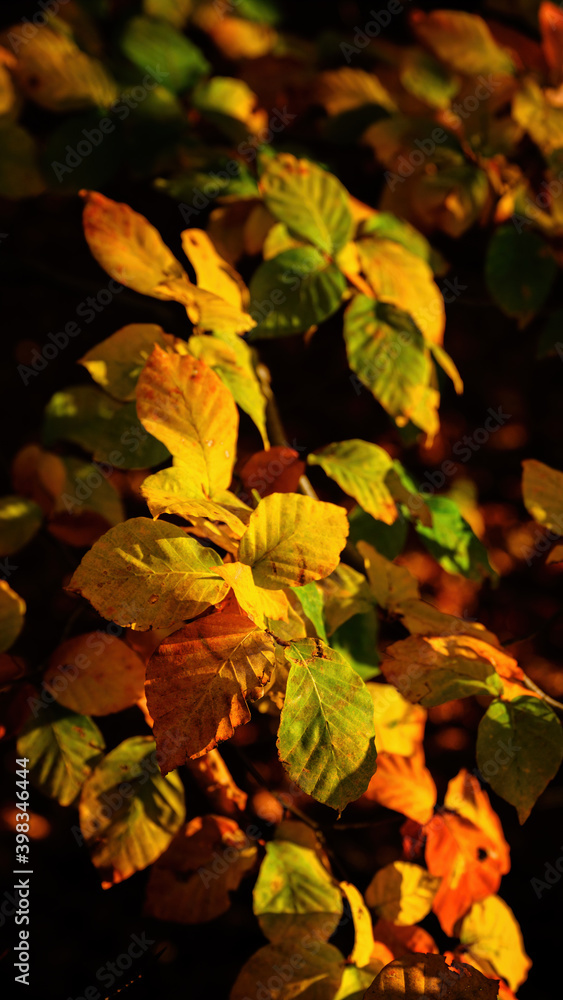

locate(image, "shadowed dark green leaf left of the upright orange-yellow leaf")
[[43, 385, 169, 469]]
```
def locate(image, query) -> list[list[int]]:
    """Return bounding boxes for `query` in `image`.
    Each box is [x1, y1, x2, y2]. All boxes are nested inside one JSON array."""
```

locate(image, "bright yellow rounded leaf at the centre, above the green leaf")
[[239, 493, 349, 590]]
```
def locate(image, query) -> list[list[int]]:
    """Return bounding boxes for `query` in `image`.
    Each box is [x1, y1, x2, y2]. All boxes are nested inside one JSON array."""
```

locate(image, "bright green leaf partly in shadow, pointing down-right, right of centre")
[[415, 497, 497, 580]]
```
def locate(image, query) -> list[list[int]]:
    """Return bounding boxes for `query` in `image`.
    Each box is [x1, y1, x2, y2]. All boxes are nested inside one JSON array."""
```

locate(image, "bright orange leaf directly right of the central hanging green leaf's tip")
[[364, 749, 437, 824]]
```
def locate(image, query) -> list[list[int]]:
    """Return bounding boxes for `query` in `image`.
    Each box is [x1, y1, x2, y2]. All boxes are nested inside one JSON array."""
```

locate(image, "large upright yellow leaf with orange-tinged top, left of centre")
[[137, 346, 238, 497]]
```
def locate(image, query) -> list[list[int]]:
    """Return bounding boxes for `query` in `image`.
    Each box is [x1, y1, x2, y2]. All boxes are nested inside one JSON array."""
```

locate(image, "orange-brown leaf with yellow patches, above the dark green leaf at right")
[[381, 635, 502, 708]]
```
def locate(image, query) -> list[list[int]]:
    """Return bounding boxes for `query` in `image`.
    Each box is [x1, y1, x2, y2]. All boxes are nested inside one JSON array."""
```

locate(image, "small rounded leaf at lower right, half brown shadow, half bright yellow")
[[366, 861, 441, 927]]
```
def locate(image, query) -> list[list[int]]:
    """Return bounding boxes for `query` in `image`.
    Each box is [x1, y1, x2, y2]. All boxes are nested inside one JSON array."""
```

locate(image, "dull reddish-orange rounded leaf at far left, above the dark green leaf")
[[43, 632, 145, 715]]
